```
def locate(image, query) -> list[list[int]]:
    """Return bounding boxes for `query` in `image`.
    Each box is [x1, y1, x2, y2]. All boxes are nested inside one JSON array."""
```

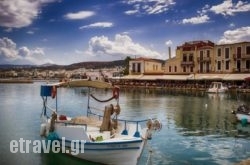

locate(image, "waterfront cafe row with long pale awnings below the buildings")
[[112, 73, 250, 88]]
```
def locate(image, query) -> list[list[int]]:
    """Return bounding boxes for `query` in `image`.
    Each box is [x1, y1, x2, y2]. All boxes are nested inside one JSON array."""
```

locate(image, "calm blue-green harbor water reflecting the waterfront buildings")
[[0, 82, 250, 165]]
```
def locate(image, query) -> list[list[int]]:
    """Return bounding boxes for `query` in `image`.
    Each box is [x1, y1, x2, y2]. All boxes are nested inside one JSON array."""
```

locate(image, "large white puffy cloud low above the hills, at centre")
[[86, 34, 161, 58]]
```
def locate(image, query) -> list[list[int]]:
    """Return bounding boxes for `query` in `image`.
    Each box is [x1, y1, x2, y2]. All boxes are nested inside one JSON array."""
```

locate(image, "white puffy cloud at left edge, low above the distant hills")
[[0, 37, 53, 64]]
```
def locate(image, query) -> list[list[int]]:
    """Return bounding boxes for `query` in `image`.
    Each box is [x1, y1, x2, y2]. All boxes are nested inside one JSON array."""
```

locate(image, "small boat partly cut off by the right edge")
[[232, 104, 250, 124]]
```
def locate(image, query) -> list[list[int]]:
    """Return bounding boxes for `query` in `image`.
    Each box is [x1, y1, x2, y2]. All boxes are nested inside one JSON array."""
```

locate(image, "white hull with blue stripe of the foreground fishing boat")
[[61, 140, 145, 165]]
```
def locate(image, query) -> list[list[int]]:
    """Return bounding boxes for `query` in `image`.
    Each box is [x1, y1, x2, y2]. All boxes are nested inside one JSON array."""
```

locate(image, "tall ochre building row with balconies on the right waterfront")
[[165, 40, 250, 74]]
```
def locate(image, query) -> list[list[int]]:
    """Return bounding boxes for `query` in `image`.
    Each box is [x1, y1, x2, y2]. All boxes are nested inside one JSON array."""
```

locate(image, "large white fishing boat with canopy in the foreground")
[[40, 80, 162, 165]]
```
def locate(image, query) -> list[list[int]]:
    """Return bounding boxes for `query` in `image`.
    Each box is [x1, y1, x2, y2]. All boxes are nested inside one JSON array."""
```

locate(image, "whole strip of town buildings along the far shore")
[[0, 40, 250, 91]]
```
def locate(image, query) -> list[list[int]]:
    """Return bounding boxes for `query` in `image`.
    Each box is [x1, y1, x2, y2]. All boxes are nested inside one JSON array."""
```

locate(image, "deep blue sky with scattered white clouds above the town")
[[0, 0, 250, 65]]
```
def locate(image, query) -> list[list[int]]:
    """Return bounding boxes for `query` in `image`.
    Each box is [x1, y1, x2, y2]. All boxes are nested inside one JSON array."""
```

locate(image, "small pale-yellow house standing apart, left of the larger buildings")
[[129, 58, 164, 75]]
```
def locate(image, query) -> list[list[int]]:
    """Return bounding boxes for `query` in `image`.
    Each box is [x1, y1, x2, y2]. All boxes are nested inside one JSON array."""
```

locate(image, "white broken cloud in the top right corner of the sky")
[[210, 0, 250, 16]]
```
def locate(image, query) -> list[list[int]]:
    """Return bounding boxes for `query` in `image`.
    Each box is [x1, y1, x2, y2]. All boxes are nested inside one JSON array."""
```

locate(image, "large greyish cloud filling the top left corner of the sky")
[[0, 0, 56, 28]]
